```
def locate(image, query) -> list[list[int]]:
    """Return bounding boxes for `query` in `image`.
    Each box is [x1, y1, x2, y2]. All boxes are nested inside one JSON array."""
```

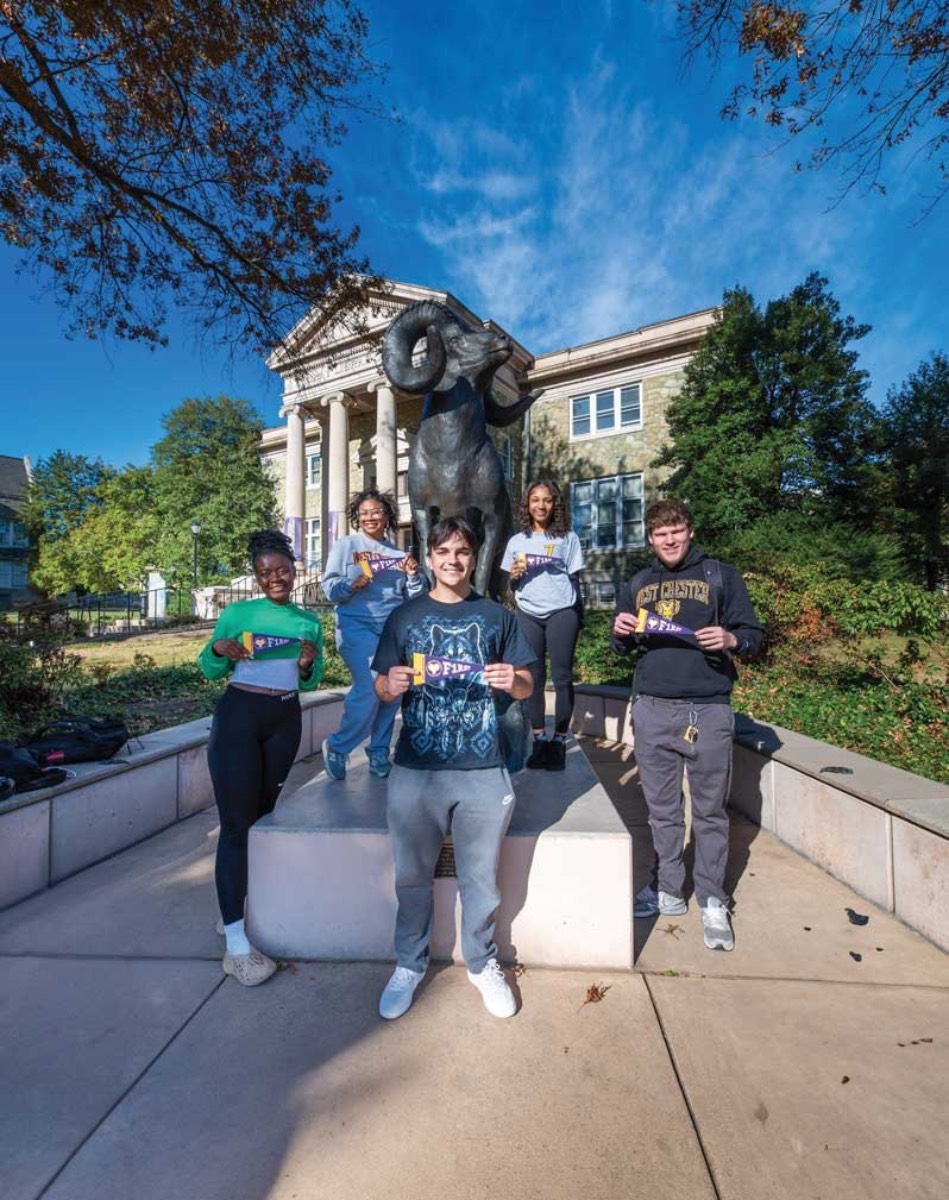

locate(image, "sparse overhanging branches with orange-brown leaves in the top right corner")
[[675, 0, 949, 204]]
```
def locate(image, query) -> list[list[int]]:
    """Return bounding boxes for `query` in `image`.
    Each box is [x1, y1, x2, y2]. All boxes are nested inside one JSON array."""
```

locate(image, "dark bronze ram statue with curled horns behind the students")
[[383, 300, 540, 599]]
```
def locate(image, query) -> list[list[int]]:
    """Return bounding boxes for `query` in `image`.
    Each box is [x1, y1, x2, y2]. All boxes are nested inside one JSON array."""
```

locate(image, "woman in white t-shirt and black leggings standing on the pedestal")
[[501, 479, 583, 770]]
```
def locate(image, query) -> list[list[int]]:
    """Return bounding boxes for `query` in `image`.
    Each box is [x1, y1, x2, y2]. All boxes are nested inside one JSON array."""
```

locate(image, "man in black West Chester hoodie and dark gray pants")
[[611, 500, 763, 950]]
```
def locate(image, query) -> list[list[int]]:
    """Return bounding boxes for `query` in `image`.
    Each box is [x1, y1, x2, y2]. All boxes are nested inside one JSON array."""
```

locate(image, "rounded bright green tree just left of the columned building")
[[151, 396, 275, 584]]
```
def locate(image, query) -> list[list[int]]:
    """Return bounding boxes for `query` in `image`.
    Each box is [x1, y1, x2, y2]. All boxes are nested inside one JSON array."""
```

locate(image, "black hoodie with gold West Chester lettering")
[[609, 547, 764, 704]]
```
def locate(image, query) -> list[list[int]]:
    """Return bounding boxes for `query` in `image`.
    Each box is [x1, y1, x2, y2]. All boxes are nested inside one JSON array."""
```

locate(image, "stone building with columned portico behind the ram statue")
[[262, 283, 715, 606]]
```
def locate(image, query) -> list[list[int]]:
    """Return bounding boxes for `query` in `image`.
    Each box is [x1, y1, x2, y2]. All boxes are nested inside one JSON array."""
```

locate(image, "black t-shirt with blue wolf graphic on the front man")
[[372, 592, 535, 770]]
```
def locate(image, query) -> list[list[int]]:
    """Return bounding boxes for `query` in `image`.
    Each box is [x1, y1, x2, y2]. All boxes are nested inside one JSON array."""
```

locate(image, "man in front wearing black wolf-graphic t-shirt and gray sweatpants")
[[372, 517, 534, 1020]]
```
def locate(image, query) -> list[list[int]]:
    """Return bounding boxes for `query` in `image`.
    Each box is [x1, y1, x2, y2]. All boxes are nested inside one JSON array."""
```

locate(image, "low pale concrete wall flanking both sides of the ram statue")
[[0, 686, 949, 949]]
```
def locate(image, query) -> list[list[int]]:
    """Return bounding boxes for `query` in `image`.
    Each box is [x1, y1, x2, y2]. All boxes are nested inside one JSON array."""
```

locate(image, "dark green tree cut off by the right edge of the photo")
[[883, 354, 949, 592]]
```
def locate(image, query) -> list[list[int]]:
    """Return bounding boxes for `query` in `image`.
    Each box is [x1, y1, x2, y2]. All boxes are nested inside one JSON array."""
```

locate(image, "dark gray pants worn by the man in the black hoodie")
[[632, 696, 734, 905]]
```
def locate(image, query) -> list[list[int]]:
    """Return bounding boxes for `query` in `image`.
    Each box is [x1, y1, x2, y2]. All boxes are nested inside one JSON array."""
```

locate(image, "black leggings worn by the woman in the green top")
[[208, 688, 301, 925]]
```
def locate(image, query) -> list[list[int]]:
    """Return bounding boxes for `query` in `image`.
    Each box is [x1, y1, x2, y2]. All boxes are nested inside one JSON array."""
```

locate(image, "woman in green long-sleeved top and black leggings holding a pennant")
[[198, 529, 323, 988]]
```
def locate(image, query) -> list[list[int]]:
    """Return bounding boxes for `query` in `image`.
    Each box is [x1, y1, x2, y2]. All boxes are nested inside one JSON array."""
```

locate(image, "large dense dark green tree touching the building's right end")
[[654, 272, 881, 541]]
